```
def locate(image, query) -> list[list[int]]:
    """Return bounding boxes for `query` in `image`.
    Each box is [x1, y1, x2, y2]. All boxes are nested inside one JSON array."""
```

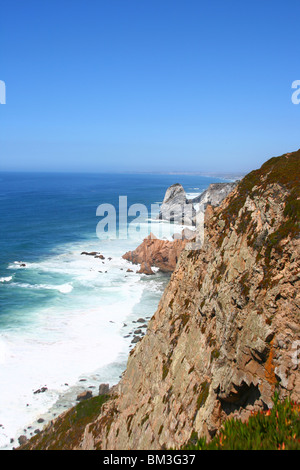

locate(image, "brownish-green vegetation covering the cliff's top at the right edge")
[[217, 150, 300, 289]]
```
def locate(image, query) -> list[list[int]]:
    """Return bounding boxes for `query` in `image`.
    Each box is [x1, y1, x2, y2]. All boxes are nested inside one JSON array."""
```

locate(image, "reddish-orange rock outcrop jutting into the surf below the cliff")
[[123, 233, 186, 274]]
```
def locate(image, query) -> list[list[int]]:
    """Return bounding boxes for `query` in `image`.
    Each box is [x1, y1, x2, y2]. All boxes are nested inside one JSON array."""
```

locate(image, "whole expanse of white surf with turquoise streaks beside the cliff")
[[0, 233, 168, 449]]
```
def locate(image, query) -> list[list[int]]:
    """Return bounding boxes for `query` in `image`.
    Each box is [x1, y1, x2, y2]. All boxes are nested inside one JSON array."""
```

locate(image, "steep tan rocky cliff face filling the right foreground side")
[[21, 151, 300, 449]]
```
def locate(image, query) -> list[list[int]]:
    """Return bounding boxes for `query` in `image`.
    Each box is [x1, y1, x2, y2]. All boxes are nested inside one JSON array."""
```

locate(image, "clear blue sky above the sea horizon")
[[0, 0, 300, 172]]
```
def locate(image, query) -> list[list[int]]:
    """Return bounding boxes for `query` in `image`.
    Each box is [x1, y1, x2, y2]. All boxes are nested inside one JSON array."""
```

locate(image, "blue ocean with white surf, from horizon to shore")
[[0, 173, 220, 449]]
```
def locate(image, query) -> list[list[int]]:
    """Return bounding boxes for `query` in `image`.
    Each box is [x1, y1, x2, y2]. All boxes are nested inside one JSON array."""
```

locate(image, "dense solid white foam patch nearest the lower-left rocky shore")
[[0, 288, 146, 447]]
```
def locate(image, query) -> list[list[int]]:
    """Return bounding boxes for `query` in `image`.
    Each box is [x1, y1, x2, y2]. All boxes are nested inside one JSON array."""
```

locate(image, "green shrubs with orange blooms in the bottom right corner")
[[184, 395, 300, 450]]
